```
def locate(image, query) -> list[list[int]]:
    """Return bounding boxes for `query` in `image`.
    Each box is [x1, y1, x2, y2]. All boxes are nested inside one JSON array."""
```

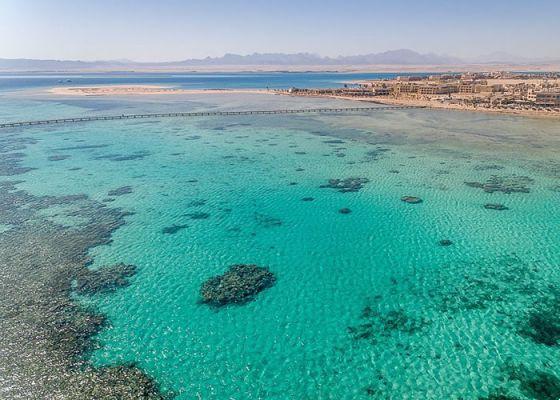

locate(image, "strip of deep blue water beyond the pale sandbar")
[[0, 72, 434, 91]]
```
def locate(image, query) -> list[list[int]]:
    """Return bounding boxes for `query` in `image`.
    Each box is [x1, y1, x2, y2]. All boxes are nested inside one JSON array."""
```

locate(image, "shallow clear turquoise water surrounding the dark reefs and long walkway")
[[0, 76, 560, 400]]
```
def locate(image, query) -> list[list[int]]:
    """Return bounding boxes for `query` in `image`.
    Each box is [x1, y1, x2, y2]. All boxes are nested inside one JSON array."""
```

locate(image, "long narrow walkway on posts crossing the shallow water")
[[0, 106, 423, 129]]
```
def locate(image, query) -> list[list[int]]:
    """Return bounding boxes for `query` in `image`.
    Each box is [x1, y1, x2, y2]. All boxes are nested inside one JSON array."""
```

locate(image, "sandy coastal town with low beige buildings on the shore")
[[280, 72, 560, 117]]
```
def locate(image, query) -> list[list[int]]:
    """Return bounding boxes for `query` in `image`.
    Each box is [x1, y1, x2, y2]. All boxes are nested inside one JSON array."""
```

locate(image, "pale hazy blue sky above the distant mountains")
[[0, 0, 560, 61]]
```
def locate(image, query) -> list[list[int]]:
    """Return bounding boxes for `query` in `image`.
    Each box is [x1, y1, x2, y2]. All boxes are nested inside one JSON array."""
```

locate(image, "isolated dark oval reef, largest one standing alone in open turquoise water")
[[200, 264, 276, 307]]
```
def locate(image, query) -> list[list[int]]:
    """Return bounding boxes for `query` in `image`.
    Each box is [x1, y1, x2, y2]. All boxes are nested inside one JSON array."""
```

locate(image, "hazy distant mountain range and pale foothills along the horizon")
[[0, 49, 560, 72]]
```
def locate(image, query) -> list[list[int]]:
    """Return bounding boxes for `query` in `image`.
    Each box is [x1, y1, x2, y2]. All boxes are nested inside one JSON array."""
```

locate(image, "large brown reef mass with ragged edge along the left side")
[[0, 182, 164, 400]]
